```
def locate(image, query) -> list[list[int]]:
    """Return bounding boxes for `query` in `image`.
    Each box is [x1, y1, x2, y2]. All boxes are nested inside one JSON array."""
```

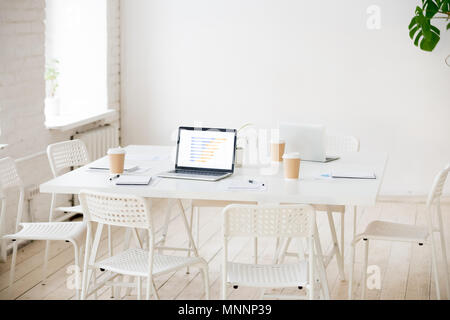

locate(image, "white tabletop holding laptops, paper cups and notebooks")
[[40, 145, 387, 205]]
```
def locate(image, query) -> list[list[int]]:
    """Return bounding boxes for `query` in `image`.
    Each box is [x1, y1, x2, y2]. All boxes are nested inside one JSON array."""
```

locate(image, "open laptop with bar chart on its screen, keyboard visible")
[[158, 127, 236, 181]]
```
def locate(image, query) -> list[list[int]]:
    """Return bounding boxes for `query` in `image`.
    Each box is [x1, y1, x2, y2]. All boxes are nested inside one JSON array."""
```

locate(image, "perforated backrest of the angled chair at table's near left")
[[79, 190, 153, 231]]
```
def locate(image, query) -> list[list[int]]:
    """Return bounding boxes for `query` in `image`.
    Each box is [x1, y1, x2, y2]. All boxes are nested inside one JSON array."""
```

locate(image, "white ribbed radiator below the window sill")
[[73, 126, 119, 161]]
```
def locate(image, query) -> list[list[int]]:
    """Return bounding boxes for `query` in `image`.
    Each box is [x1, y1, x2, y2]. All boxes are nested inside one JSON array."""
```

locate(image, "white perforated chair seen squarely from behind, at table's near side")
[[222, 204, 329, 299]]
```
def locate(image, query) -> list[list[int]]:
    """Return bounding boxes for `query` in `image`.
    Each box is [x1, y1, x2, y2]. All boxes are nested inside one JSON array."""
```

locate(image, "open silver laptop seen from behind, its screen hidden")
[[279, 123, 339, 162]]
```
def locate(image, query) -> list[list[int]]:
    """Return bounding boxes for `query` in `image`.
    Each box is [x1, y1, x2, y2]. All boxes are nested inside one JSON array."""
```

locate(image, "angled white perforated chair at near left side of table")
[[79, 191, 209, 299]]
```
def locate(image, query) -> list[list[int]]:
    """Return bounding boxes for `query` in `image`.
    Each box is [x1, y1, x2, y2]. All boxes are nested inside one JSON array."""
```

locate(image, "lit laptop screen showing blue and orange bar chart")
[[176, 127, 236, 172]]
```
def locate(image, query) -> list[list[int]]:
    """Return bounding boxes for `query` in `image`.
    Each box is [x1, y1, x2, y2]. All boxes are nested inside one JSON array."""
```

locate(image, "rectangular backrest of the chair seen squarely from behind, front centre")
[[223, 204, 315, 238]]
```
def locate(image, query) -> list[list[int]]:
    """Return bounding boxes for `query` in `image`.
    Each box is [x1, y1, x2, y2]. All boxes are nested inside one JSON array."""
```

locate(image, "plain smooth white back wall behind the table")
[[121, 0, 450, 194]]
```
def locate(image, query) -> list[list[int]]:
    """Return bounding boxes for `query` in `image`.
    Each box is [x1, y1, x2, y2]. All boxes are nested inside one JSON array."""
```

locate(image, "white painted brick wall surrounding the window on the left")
[[0, 0, 120, 248]]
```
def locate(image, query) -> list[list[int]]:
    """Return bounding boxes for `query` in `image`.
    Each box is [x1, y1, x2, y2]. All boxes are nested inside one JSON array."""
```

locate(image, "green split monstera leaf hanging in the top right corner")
[[408, 0, 450, 51]]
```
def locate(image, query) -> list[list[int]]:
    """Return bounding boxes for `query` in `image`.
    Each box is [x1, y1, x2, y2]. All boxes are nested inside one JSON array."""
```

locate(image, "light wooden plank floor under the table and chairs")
[[0, 200, 450, 299]]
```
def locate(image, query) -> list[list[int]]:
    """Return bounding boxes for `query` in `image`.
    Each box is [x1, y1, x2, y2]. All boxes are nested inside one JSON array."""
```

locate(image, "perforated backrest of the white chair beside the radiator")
[[47, 139, 89, 177]]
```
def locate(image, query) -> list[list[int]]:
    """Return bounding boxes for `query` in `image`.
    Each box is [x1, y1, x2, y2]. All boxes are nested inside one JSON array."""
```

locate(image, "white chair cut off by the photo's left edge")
[[0, 158, 86, 298]]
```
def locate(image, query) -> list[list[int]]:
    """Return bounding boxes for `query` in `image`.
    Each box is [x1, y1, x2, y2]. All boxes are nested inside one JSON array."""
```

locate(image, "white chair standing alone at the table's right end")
[[348, 164, 450, 299]]
